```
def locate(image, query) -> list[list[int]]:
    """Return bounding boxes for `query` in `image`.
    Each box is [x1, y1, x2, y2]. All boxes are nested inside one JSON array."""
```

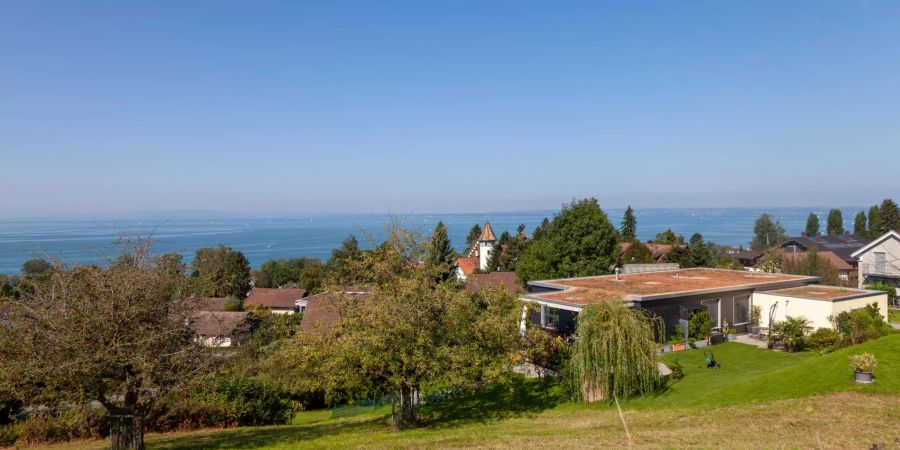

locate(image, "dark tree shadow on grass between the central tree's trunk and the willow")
[[421, 377, 564, 428]]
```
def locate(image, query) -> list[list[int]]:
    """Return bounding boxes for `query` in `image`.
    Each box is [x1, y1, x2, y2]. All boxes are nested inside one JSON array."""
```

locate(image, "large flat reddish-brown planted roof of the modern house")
[[525, 268, 819, 306]]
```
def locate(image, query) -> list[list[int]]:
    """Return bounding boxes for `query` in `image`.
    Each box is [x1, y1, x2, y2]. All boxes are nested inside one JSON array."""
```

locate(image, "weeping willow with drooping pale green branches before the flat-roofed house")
[[570, 302, 663, 402]]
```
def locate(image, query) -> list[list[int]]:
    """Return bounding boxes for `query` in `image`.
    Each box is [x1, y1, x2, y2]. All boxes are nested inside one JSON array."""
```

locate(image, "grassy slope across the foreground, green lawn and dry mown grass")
[[40, 334, 900, 449]]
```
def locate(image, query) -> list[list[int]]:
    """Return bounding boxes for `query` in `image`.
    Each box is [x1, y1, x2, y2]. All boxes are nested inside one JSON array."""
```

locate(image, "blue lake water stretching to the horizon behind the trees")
[[0, 207, 863, 274]]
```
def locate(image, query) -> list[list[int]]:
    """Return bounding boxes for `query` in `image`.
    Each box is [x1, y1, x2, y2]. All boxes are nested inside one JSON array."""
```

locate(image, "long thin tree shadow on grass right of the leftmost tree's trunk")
[[148, 416, 388, 450]]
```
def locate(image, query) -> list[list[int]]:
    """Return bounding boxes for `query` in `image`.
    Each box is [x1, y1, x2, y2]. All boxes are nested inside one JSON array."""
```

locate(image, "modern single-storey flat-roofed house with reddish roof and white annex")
[[522, 268, 887, 335]]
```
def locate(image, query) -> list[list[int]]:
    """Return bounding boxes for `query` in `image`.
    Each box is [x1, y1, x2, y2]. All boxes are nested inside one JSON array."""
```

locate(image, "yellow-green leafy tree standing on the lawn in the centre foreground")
[[268, 224, 521, 428]]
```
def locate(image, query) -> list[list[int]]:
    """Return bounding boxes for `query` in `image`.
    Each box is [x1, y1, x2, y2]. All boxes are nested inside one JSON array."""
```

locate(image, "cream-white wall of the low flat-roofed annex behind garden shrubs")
[[752, 292, 887, 328]]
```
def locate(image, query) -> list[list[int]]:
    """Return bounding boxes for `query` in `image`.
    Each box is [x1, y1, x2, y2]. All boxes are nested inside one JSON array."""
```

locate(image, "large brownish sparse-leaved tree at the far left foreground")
[[0, 246, 206, 448]]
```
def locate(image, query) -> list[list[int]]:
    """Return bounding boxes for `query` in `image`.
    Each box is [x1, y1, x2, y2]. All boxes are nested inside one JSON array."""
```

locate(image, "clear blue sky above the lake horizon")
[[0, 0, 900, 217]]
